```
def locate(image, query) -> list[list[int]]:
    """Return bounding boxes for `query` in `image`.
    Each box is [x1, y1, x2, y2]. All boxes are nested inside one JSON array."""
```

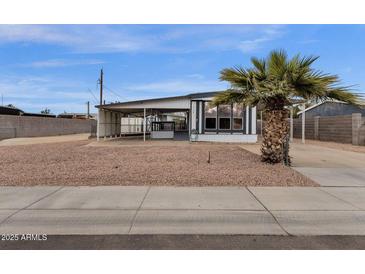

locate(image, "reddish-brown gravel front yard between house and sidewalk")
[[0, 141, 317, 186]]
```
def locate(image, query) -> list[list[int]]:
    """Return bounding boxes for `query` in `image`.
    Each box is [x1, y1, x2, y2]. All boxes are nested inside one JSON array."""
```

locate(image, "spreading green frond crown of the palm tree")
[[214, 50, 360, 109]]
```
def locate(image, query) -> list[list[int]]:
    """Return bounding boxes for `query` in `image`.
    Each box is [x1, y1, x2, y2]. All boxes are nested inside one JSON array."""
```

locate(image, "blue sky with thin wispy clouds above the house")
[[0, 25, 365, 113]]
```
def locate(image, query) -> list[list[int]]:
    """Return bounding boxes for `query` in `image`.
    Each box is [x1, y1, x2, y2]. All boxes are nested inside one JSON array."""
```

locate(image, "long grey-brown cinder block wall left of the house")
[[0, 115, 96, 139]]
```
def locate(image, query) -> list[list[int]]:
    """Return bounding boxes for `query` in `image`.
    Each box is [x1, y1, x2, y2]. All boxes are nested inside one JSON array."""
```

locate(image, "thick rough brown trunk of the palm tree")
[[261, 110, 289, 164]]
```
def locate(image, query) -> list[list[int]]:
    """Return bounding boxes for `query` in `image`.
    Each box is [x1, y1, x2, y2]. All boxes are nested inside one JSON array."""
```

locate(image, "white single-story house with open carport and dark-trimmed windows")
[[96, 91, 257, 143]]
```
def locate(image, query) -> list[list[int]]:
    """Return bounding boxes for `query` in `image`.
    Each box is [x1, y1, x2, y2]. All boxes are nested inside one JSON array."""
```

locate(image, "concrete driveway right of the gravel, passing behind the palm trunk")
[[241, 142, 365, 187]]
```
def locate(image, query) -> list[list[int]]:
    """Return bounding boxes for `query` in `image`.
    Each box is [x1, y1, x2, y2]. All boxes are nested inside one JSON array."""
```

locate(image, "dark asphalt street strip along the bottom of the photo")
[[0, 235, 365, 250]]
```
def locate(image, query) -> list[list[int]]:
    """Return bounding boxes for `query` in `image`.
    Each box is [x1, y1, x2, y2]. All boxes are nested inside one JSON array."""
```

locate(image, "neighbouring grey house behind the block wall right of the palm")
[[298, 101, 365, 118]]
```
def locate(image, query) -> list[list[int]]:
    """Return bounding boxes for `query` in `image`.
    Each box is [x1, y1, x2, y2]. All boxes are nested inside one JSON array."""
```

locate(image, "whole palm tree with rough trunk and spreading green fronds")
[[212, 50, 359, 163]]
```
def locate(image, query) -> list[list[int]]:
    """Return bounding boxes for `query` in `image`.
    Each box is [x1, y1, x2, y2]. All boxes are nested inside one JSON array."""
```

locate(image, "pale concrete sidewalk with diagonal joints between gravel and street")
[[0, 186, 365, 235]]
